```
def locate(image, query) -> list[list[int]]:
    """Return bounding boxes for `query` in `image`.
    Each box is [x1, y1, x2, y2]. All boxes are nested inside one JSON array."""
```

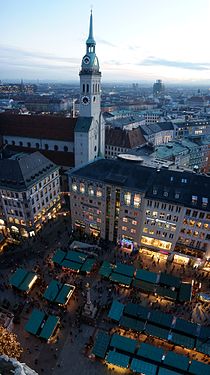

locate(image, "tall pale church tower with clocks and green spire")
[[74, 11, 105, 167]]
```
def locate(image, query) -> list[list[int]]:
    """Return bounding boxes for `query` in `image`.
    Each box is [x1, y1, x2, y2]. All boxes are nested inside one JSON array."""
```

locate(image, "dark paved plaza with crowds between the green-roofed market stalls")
[[0, 217, 210, 375]]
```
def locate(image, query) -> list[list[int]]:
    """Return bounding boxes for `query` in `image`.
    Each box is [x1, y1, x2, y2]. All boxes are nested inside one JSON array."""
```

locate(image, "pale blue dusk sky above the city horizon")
[[0, 0, 210, 83]]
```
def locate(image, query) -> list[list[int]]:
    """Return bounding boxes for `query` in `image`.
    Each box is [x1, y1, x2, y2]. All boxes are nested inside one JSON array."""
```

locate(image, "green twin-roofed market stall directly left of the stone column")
[[43, 280, 75, 305]]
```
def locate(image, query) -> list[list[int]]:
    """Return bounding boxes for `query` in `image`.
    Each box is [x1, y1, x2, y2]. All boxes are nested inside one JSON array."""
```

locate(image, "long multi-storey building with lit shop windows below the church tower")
[[69, 156, 210, 257]]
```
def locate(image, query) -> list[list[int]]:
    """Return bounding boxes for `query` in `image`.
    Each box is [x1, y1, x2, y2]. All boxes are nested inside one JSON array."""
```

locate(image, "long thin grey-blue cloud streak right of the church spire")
[[139, 56, 210, 71]]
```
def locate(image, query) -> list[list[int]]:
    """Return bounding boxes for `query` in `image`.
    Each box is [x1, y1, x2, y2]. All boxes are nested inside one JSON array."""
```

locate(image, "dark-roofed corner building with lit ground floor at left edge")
[[0, 152, 61, 237]]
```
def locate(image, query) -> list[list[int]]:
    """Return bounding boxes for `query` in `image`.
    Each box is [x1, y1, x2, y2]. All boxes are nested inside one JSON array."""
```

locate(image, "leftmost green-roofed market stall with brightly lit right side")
[[10, 268, 37, 292]]
